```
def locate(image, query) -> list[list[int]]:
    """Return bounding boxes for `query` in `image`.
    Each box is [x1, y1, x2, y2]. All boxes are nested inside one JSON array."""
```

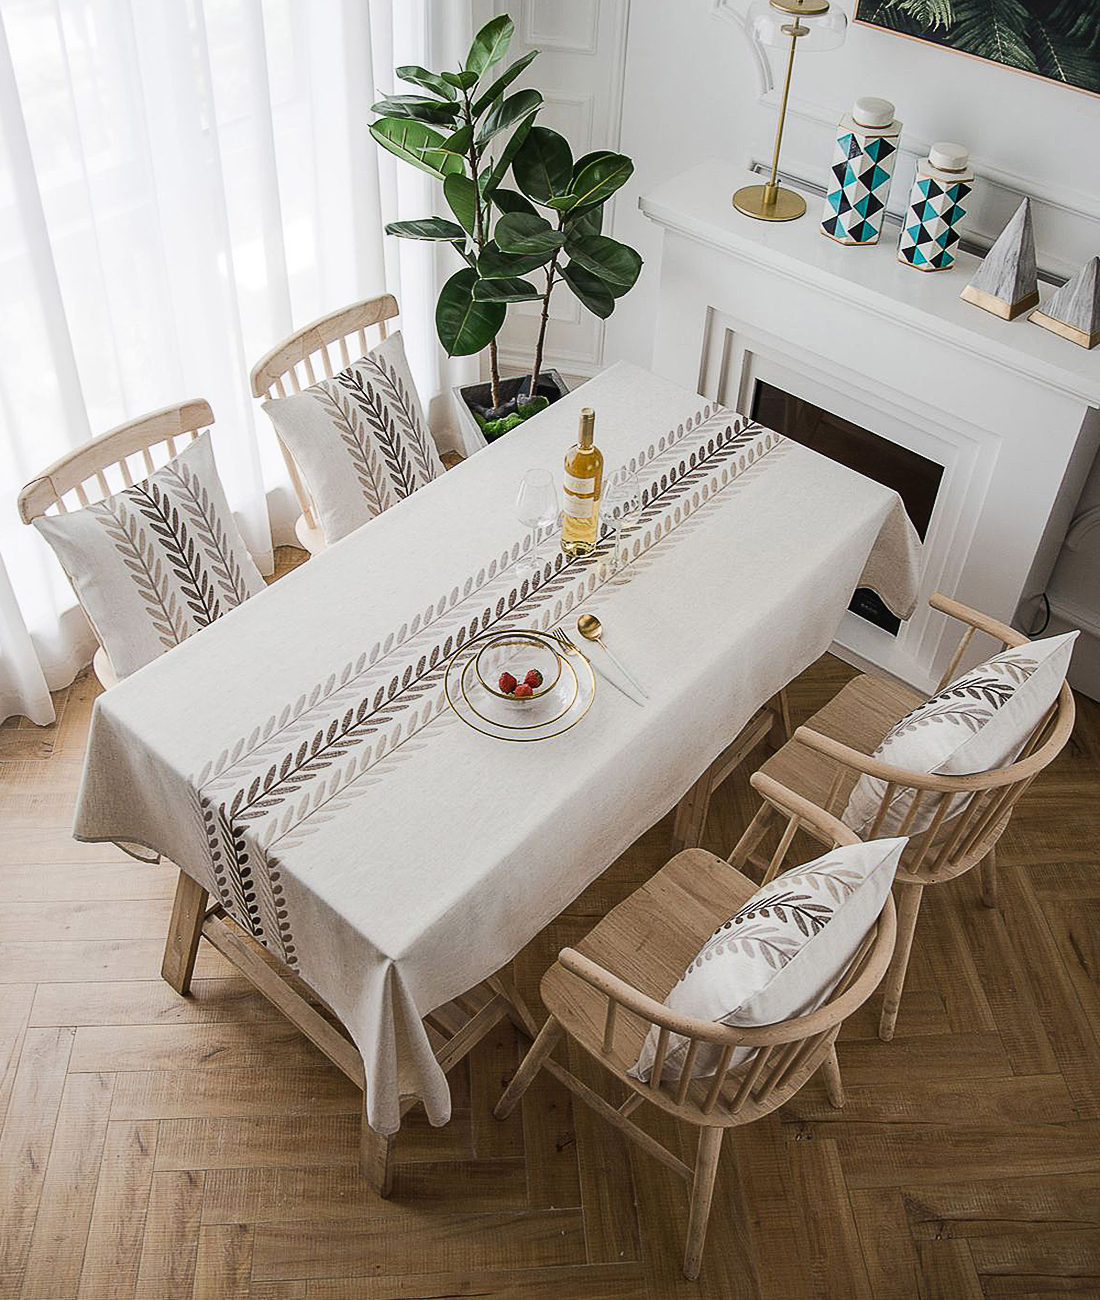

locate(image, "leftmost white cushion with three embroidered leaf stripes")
[[34, 433, 264, 677]]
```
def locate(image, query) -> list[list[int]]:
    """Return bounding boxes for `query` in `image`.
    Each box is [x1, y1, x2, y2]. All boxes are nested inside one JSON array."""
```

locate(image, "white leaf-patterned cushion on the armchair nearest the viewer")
[[631, 840, 906, 1080]]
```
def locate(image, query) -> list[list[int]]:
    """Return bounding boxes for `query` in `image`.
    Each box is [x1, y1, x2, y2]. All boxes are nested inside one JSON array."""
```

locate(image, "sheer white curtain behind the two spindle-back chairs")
[[0, 0, 472, 723]]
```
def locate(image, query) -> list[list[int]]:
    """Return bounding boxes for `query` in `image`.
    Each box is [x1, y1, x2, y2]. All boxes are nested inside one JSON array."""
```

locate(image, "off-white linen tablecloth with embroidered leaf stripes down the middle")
[[74, 364, 919, 1134]]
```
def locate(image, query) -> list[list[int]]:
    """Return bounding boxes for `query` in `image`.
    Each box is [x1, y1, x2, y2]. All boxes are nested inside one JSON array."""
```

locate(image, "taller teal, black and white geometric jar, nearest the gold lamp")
[[822, 95, 901, 244]]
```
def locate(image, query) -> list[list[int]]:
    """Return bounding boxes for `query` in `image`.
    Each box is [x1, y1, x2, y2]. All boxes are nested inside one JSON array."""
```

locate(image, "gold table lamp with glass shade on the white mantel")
[[733, 0, 848, 221]]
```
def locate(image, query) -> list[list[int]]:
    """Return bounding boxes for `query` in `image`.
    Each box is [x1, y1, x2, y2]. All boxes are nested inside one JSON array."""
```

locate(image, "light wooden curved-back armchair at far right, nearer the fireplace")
[[729, 594, 1074, 1041]]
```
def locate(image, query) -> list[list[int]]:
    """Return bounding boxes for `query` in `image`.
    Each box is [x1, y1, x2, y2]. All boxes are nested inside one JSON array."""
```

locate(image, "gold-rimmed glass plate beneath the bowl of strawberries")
[[443, 632, 596, 742]]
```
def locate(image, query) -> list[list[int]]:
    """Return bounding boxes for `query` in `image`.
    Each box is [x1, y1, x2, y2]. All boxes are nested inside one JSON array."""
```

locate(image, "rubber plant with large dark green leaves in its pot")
[[371, 14, 642, 451]]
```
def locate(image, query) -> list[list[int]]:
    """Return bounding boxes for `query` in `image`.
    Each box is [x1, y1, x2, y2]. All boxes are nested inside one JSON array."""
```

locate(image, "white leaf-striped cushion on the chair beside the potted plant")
[[264, 330, 443, 545]]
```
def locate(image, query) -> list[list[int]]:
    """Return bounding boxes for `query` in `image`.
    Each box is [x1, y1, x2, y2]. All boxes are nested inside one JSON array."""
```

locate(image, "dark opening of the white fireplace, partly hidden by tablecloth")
[[752, 380, 944, 636]]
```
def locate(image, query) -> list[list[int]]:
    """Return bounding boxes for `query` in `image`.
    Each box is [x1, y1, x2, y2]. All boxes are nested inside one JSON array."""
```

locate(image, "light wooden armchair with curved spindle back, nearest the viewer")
[[495, 774, 895, 1279]]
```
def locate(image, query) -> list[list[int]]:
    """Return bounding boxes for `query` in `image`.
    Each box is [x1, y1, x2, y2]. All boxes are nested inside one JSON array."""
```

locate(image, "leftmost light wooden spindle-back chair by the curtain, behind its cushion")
[[18, 398, 213, 690]]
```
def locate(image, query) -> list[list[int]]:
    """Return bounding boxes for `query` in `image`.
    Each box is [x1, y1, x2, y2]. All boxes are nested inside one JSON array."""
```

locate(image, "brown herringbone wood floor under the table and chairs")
[[0, 551, 1100, 1300]]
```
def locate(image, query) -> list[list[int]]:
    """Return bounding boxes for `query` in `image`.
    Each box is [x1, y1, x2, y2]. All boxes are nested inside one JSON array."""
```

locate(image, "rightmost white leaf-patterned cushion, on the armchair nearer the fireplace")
[[841, 632, 1077, 835]]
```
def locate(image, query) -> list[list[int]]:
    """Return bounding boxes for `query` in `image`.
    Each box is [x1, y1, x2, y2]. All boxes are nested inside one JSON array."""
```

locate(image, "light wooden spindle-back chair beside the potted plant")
[[251, 294, 398, 555]]
